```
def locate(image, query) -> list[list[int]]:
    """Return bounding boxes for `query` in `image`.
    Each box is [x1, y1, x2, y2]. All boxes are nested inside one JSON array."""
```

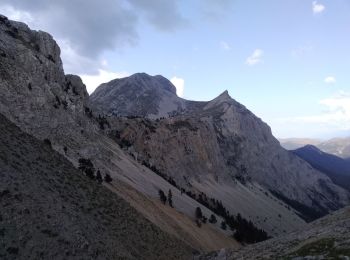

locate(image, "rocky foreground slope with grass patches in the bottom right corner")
[[195, 207, 350, 260]]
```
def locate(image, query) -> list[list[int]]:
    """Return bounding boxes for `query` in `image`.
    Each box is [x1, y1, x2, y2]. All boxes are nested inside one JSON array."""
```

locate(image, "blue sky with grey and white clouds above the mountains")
[[0, 0, 350, 139]]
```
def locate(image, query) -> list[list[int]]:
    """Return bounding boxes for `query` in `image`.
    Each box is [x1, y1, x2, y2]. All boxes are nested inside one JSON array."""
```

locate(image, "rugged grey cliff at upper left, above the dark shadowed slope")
[[0, 16, 93, 143]]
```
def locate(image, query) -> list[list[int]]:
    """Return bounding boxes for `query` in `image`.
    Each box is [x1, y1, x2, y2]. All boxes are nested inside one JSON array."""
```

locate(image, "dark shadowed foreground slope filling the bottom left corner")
[[0, 112, 193, 259]]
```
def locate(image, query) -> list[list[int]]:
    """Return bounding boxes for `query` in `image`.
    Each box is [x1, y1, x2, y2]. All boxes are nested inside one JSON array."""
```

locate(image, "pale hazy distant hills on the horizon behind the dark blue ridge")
[[279, 137, 350, 159]]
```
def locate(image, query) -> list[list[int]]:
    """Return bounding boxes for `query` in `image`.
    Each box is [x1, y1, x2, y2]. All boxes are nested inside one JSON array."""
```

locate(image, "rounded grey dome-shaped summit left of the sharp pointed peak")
[[90, 73, 187, 118]]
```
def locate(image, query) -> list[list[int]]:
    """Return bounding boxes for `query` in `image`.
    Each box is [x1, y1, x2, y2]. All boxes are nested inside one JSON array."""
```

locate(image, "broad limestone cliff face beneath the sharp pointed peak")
[[97, 76, 349, 217]]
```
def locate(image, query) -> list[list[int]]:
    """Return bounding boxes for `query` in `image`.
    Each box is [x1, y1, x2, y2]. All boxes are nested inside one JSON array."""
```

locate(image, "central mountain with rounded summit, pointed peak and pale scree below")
[[90, 74, 349, 228]]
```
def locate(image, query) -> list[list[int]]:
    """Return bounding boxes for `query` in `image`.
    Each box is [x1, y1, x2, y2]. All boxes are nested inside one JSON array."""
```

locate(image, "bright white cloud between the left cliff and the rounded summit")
[[79, 69, 129, 94]]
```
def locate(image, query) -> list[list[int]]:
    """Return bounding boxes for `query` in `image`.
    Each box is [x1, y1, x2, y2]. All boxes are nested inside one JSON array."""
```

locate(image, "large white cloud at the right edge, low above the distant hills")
[[279, 91, 350, 131]]
